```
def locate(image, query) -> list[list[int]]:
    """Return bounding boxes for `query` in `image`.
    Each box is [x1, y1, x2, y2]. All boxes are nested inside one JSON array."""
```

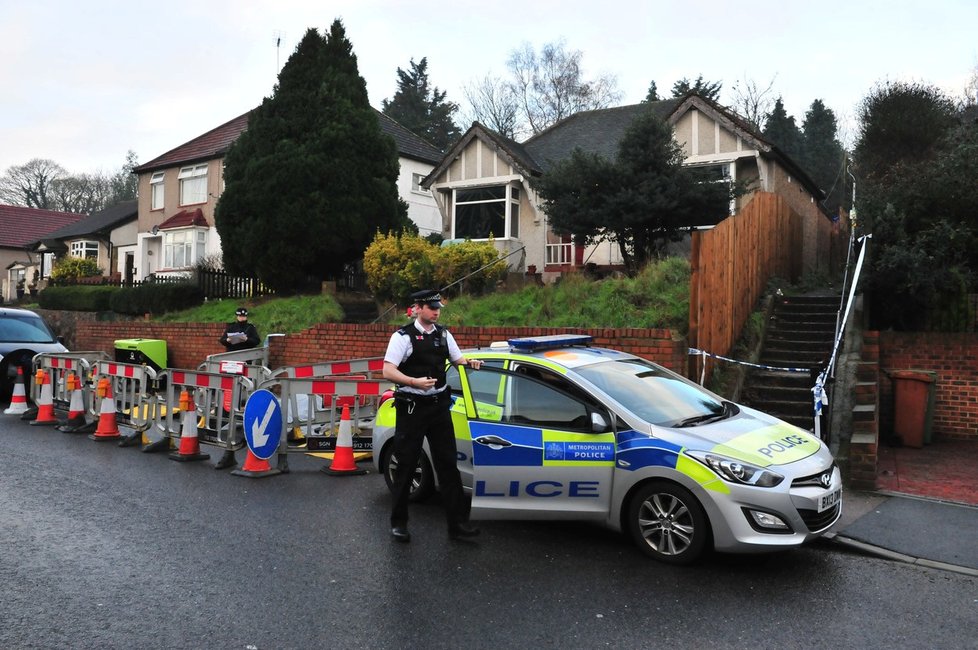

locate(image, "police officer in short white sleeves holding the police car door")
[[384, 289, 482, 542]]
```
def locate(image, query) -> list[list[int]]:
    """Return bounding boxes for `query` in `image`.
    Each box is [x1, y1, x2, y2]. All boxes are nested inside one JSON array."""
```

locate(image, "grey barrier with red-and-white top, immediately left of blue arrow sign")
[[155, 368, 255, 451]]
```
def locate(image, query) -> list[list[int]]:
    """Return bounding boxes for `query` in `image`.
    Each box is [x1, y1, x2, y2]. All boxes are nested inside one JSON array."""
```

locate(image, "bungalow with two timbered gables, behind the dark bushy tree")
[[423, 93, 830, 280]]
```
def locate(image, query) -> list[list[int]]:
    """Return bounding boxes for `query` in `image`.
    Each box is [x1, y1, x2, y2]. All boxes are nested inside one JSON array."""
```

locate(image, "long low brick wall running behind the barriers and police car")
[[69, 321, 687, 373]]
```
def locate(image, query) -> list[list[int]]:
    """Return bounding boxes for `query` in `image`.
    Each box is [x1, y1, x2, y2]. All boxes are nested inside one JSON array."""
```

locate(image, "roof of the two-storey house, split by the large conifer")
[[132, 108, 442, 174]]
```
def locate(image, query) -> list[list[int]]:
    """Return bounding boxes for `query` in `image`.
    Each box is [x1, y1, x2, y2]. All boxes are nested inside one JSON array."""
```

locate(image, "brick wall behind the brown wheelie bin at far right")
[[880, 332, 978, 441]]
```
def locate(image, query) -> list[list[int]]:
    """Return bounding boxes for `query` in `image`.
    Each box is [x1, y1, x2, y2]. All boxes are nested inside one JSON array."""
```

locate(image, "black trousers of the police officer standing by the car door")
[[391, 390, 468, 526]]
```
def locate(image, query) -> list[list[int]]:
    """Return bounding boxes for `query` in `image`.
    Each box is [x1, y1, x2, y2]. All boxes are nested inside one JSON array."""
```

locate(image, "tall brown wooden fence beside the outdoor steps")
[[688, 192, 804, 377]]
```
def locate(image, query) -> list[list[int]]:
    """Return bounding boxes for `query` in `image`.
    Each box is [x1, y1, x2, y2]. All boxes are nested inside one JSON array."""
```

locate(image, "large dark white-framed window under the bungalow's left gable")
[[453, 185, 520, 239]]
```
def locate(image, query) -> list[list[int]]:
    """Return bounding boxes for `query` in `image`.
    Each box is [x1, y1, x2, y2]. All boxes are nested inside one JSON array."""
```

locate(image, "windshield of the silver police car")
[[576, 359, 732, 427]]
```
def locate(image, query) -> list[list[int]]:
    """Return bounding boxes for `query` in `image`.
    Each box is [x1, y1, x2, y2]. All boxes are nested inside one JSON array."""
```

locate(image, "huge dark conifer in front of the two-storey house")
[[215, 20, 410, 293]]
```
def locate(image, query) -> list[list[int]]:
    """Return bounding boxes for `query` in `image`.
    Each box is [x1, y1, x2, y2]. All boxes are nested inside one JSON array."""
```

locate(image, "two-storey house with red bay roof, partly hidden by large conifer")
[[133, 111, 442, 280]]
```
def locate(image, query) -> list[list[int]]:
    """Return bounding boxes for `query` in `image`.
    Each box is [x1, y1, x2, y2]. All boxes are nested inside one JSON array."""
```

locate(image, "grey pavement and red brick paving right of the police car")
[[826, 440, 978, 577]]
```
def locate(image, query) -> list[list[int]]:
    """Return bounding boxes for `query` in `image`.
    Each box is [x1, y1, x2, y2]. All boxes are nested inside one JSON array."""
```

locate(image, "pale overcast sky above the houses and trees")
[[0, 0, 978, 174]]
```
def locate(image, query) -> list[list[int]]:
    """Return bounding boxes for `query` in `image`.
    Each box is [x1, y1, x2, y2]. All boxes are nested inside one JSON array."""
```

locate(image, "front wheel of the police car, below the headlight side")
[[628, 481, 709, 564]]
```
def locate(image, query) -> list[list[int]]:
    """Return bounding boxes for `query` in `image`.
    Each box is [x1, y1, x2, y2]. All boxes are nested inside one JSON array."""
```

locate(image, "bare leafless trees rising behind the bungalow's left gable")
[[465, 40, 621, 137]]
